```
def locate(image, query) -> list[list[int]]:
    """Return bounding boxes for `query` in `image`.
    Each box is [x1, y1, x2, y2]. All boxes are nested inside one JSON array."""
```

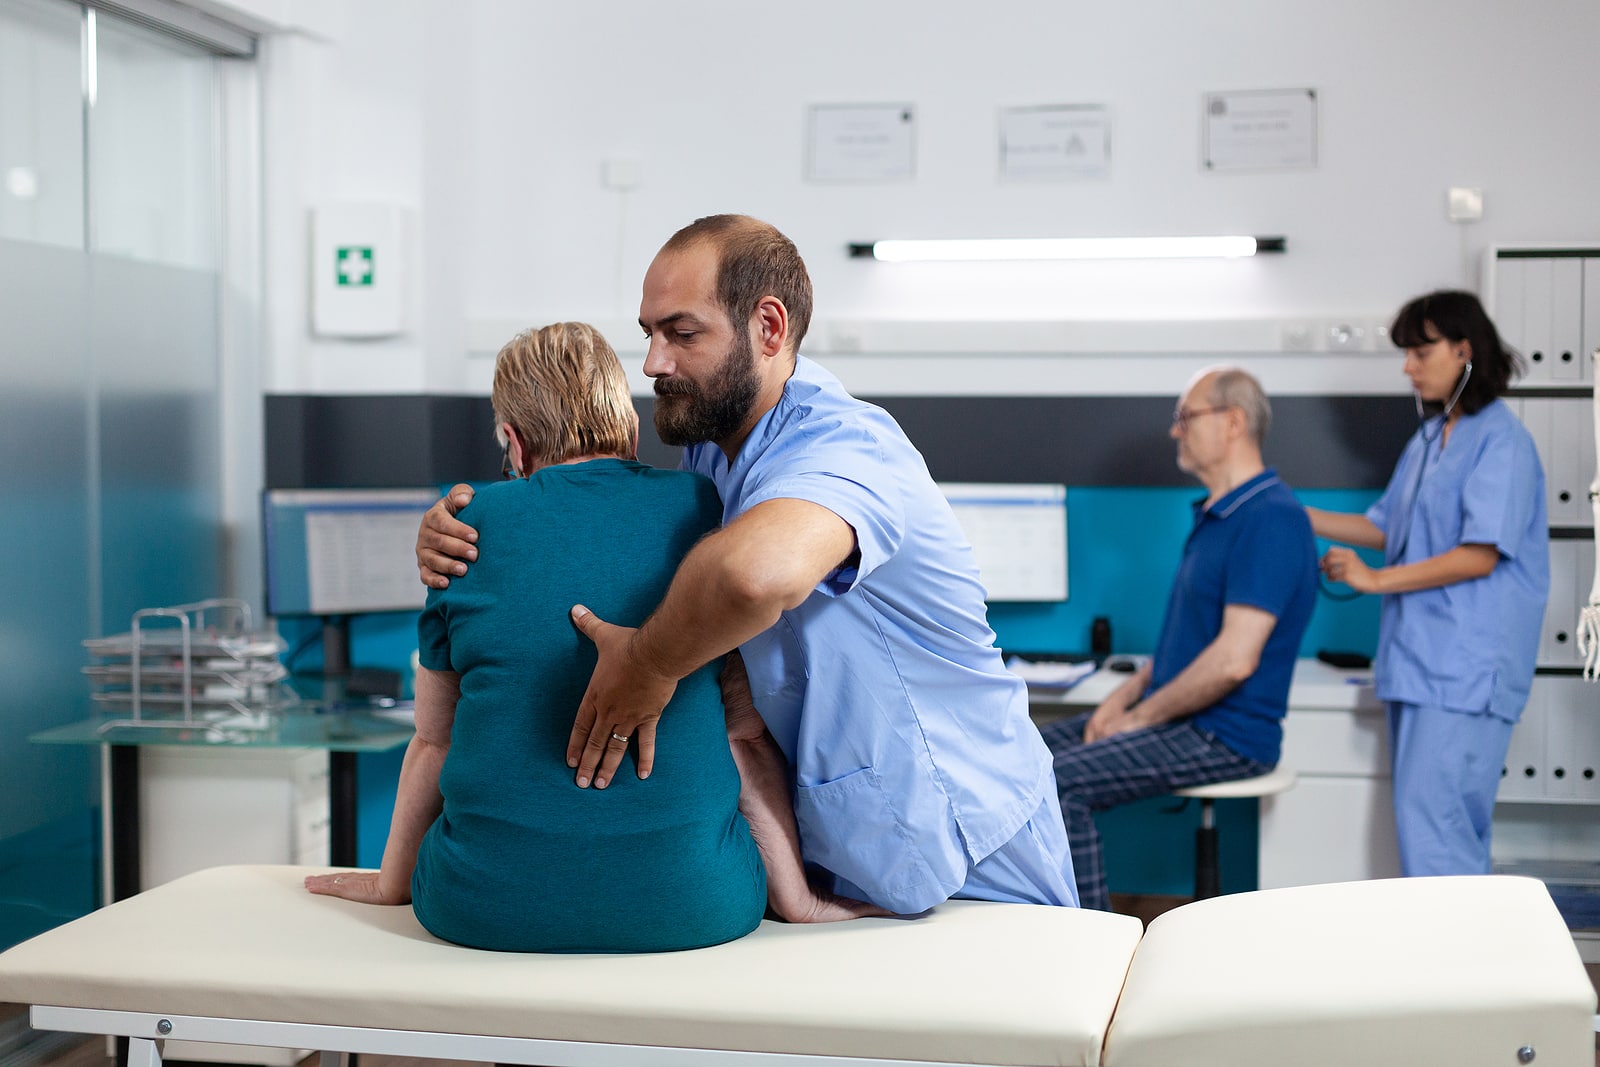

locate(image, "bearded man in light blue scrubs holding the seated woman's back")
[[418, 216, 1077, 913]]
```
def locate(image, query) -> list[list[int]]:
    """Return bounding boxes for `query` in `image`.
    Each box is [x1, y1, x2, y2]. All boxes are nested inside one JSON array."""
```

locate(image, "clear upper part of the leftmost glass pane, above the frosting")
[[0, 0, 83, 248]]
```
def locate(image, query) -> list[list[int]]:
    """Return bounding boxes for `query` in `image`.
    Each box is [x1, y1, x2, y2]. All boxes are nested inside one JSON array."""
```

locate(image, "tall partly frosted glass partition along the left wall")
[[0, 0, 243, 949]]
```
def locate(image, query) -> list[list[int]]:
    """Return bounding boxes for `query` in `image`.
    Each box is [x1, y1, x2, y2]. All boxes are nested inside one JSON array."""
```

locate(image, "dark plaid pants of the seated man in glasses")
[[1038, 712, 1272, 912]]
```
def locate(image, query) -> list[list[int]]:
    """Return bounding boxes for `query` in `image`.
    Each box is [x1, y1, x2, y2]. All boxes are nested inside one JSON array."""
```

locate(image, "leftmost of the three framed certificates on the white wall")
[[805, 104, 917, 184]]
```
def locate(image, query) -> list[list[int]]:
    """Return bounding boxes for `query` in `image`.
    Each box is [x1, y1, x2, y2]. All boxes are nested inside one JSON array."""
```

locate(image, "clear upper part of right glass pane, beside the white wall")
[[88, 11, 218, 267]]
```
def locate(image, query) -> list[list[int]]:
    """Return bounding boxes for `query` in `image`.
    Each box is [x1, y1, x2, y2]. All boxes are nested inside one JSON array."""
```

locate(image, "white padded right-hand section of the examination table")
[[1106, 875, 1595, 1067]]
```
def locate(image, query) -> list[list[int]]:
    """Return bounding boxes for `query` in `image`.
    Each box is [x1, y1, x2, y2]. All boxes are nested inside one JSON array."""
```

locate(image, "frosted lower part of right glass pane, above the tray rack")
[[91, 256, 224, 633]]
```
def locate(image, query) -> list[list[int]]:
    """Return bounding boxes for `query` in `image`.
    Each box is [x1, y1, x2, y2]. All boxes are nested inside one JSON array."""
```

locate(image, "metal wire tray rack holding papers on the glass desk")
[[83, 598, 299, 733]]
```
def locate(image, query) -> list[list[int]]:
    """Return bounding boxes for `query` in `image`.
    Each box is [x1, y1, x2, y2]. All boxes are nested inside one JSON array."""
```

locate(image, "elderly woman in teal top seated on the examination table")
[[306, 323, 861, 952]]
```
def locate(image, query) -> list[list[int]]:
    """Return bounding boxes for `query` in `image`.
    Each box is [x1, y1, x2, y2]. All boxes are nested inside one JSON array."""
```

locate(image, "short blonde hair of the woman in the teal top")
[[490, 322, 638, 472]]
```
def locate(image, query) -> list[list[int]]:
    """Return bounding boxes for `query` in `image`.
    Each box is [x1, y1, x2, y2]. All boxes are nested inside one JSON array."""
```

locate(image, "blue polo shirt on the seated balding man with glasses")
[[1150, 469, 1317, 763]]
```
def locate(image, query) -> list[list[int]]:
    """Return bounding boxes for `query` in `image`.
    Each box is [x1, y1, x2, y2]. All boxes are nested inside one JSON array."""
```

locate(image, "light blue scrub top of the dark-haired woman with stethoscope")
[[1366, 400, 1550, 721]]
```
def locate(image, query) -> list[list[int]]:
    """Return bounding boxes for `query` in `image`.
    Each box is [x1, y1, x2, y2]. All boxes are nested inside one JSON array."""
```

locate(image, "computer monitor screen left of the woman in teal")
[[261, 486, 440, 616]]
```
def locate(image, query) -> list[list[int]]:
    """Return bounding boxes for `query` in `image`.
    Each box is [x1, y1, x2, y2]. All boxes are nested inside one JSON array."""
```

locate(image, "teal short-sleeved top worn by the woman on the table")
[[413, 459, 766, 952]]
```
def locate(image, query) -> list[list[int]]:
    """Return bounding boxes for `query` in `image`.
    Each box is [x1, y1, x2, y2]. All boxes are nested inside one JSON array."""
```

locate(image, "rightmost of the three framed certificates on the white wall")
[[1200, 88, 1318, 173]]
